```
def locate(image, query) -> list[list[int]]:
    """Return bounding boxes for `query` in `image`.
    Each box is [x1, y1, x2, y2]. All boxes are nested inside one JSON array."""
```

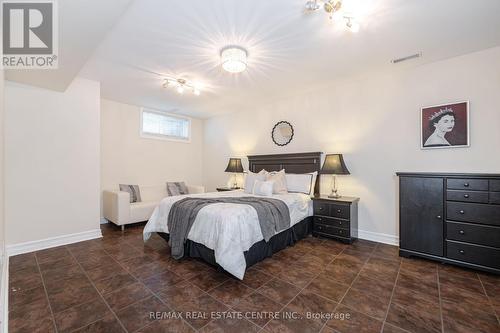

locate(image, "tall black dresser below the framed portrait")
[[397, 172, 500, 274]]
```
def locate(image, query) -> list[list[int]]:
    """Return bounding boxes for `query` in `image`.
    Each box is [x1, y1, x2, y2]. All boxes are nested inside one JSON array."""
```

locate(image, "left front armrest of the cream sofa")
[[102, 191, 130, 225]]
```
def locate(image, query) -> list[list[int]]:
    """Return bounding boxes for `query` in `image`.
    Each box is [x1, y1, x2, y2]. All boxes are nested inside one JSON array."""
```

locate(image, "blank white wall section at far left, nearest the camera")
[[5, 78, 100, 247]]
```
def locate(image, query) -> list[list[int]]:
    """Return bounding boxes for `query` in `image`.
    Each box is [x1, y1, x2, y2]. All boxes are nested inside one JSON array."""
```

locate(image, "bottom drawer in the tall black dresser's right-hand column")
[[446, 241, 500, 268]]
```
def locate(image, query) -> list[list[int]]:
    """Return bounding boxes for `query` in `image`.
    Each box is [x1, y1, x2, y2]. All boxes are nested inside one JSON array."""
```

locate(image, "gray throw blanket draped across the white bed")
[[168, 197, 290, 259]]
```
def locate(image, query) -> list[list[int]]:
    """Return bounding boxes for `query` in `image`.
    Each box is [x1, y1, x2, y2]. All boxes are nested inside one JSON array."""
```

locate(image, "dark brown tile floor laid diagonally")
[[9, 225, 500, 333]]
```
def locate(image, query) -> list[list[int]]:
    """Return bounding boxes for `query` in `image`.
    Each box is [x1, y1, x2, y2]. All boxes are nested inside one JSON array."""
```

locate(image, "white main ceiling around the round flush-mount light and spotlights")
[[6, 0, 500, 118]]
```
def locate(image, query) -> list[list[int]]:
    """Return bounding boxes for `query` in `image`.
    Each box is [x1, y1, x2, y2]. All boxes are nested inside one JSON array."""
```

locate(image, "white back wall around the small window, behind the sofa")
[[101, 99, 203, 213]]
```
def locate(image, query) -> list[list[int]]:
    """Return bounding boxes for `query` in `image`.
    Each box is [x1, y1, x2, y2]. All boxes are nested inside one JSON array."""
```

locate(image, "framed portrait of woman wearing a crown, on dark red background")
[[420, 101, 470, 149]]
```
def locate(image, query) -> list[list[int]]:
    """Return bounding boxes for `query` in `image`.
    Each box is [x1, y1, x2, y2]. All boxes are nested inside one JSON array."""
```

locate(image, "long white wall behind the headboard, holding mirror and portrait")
[[203, 48, 500, 242]]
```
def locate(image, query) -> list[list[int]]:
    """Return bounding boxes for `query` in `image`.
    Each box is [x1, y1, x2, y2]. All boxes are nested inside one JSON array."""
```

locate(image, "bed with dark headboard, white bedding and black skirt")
[[144, 152, 321, 279]]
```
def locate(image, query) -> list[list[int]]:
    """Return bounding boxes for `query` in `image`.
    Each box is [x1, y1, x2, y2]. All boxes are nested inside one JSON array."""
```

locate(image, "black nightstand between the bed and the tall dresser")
[[313, 196, 359, 244]]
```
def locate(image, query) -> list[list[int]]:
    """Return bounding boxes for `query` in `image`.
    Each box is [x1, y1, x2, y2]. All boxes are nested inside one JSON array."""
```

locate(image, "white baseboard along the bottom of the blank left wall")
[[7, 229, 102, 257]]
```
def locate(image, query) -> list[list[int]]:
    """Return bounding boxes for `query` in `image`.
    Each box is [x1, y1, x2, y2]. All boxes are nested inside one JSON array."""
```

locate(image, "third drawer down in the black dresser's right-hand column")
[[446, 201, 500, 225]]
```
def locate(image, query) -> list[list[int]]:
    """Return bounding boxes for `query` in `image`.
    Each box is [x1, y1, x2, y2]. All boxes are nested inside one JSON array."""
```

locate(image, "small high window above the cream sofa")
[[141, 108, 191, 142]]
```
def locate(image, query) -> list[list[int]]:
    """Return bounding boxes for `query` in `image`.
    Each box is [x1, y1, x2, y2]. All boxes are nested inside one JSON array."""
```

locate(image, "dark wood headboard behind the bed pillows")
[[248, 152, 323, 195]]
